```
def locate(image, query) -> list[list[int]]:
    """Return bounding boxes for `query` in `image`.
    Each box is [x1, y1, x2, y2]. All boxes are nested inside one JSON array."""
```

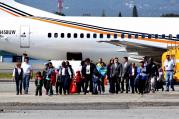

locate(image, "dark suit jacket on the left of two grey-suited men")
[[111, 63, 123, 77]]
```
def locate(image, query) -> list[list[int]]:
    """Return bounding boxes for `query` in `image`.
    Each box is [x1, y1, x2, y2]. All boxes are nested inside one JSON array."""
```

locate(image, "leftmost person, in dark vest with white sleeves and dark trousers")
[[12, 62, 23, 95]]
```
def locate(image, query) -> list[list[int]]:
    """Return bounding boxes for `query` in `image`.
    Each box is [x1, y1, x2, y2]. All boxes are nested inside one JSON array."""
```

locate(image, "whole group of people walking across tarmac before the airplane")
[[13, 55, 175, 96]]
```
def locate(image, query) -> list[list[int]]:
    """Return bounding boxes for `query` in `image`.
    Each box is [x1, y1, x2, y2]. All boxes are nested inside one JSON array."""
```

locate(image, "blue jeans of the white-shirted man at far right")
[[166, 71, 174, 90]]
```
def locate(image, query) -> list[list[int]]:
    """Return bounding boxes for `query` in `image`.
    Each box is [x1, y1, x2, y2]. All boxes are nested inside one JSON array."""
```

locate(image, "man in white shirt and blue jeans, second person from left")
[[21, 57, 33, 94]]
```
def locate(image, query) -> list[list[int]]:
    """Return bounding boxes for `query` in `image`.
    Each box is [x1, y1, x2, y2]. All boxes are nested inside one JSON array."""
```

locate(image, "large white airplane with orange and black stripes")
[[0, 0, 179, 61]]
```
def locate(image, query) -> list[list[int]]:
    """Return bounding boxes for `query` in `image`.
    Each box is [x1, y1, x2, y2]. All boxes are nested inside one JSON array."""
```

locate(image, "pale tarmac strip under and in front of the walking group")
[[0, 82, 179, 110]]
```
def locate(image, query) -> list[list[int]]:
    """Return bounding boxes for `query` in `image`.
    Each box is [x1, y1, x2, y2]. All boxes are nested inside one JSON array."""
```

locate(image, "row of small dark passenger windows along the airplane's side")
[[48, 33, 179, 40]]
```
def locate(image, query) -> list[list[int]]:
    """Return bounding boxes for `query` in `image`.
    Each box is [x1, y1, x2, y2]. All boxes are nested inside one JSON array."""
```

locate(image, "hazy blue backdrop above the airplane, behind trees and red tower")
[[16, 0, 179, 17]]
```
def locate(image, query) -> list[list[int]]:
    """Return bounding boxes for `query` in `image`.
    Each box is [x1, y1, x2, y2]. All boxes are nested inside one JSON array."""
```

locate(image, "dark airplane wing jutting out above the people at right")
[[98, 40, 166, 62]]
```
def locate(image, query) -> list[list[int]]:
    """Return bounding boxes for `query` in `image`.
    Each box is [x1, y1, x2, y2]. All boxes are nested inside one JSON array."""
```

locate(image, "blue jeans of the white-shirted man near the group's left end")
[[23, 74, 30, 94]]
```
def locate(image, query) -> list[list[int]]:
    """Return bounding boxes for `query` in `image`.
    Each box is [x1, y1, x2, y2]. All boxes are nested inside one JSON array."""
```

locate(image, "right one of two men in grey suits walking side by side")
[[121, 57, 130, 93]]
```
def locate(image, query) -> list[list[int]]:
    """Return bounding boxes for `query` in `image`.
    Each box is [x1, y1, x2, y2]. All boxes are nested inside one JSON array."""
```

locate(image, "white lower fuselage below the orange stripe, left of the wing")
[[0, 17, 127, 60]]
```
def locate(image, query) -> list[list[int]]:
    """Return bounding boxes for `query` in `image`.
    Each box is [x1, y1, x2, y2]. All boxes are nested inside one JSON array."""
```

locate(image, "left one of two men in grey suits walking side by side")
[[111, 57, 122, 94]]
